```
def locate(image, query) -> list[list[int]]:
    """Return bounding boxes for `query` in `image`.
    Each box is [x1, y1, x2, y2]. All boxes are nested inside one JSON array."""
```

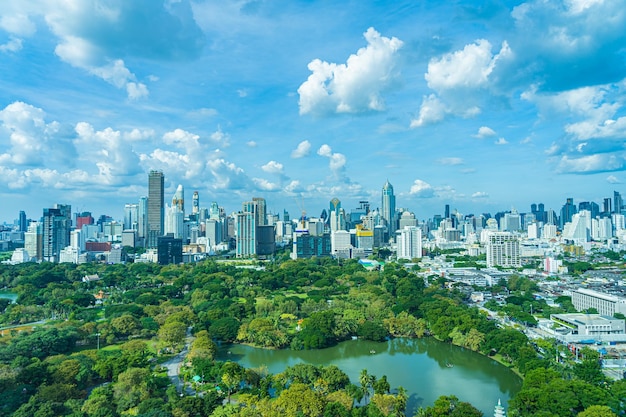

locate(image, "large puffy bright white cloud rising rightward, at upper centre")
[[298, 28, 403, 115]]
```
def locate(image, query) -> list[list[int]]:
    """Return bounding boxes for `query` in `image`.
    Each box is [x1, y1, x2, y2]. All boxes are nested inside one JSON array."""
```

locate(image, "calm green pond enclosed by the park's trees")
[[218, 338, 522, 416]]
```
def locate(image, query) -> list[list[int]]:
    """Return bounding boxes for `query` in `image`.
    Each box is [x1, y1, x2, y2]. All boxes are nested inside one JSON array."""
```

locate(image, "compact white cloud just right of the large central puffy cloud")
[[424, 39, 511, 91]]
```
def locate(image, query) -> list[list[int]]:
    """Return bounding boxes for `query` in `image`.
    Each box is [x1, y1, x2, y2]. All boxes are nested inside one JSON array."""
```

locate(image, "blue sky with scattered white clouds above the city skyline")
[[0, 0, 626, 221]]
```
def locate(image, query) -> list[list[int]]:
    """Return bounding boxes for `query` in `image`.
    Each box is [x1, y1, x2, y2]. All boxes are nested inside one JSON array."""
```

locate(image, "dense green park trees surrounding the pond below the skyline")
[[0, 259, 626, 417]]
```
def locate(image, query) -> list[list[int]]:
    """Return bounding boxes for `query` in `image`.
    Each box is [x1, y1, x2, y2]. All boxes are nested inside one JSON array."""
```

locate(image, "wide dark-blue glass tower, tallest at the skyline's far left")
[[42, 204, 72, 262]]
